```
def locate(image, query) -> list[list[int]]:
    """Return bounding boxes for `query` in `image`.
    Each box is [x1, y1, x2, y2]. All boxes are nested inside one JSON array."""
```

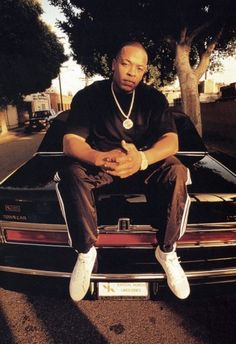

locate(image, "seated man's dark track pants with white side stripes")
[[56, 157, 191, 253]]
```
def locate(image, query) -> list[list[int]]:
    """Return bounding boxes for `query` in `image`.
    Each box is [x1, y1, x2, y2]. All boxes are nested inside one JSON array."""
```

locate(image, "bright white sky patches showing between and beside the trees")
[[39, 0, 236, 95]]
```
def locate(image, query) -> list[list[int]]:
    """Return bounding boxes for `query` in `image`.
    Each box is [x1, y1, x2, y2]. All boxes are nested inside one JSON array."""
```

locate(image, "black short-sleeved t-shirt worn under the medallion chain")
[[66, 80, 176, 151]]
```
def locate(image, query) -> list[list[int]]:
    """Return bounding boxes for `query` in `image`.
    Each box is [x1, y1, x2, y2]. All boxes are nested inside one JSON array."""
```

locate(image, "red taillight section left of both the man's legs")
[[4, 228, 68, 245]]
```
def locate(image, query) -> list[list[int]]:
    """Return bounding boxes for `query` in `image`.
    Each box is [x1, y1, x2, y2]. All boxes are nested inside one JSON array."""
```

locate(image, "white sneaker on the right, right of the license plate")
[[155, 246, 190, 299]]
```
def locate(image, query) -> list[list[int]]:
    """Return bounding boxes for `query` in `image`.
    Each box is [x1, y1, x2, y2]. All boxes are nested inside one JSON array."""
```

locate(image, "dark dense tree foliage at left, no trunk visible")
[[0, 0, 66, 106]]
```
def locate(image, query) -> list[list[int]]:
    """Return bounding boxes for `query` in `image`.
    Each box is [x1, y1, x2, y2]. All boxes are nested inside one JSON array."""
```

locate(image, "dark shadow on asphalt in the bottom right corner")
[[163, 283, 236, 344]]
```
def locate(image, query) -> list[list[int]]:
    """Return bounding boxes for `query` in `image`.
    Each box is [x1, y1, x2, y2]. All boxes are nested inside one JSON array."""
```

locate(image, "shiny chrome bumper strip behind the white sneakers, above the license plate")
[[0, 266, 236, 281]]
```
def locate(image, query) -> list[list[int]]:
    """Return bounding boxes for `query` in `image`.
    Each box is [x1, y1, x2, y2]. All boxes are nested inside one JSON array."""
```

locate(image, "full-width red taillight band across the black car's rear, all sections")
[[3, 227, 236, 247]]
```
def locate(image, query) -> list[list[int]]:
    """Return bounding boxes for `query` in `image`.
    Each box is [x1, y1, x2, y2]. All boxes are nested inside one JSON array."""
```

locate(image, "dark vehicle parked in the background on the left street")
[[24, 109, 56, 133]]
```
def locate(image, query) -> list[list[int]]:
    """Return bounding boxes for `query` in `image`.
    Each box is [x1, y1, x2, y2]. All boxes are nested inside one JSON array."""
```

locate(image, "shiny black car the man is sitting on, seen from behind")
[[0, 112, 236, 298]]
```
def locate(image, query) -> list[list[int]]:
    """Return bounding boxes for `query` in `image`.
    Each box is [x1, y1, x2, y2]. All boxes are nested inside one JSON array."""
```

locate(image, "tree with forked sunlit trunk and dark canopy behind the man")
[[51, 0, 236, 133]]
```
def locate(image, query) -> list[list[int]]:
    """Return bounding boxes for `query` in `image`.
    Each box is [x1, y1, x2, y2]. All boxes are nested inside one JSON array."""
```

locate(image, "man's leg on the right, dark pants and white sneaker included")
[[146, 157, 191, 299]]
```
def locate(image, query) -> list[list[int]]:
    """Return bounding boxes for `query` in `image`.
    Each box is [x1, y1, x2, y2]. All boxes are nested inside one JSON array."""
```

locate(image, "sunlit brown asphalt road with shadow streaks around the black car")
[[0, 132, 236, 344]]
